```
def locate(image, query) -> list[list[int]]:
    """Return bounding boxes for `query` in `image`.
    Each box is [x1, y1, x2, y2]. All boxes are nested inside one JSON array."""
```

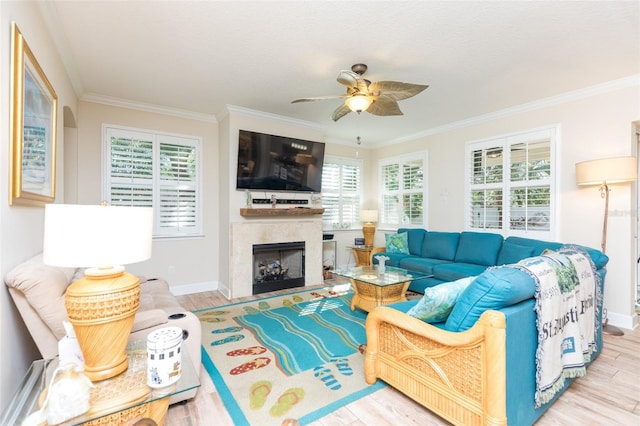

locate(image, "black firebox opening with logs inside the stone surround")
[[253, 241, 305, 294]]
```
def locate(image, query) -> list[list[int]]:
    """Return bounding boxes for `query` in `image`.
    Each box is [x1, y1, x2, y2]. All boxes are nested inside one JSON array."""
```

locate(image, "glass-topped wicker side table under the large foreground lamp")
[[0, 340, 200, 426]]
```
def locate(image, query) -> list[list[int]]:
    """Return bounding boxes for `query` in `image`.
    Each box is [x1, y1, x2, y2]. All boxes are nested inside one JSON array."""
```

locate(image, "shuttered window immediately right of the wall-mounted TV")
[[322, 156, 362, 229]]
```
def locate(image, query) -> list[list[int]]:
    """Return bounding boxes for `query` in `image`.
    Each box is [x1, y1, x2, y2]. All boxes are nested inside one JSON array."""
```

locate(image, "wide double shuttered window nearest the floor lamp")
[[465, 128, 557, 238]]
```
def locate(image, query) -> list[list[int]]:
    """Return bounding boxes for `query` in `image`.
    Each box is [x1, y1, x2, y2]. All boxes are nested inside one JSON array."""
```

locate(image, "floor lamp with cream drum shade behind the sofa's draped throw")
[[576, 157, 638, 336]]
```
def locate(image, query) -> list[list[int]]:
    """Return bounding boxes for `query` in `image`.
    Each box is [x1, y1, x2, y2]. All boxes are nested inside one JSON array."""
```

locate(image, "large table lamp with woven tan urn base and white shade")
[[43, 204, 153, 381]]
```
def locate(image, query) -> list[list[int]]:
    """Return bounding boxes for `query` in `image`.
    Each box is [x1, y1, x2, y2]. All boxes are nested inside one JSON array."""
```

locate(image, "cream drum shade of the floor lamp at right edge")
[[576, 157, 638, 185]]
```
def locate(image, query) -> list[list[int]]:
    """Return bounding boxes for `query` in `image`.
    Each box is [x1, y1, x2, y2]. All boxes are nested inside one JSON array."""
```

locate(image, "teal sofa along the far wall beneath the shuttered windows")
[[372, 228, 608, 293]]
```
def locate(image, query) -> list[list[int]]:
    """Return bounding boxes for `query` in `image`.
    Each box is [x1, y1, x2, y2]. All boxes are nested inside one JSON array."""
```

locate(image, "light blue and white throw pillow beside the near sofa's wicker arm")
[[407, 277, 475, 322]]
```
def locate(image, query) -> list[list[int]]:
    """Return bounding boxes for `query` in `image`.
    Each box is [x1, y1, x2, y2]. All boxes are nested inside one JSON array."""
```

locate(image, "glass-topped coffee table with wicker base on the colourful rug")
[[333, 265, 433, 312]]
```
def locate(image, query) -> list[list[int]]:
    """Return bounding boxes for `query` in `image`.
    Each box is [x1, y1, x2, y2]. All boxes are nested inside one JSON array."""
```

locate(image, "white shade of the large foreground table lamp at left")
[[43, 204, 153, 267]]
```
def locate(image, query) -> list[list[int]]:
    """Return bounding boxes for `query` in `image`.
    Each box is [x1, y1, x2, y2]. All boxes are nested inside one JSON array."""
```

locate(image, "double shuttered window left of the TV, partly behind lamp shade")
[[103, 126, 202, 237]]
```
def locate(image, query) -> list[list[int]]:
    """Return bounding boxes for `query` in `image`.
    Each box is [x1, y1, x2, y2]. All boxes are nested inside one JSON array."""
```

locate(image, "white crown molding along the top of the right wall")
[[373, 74, 640, 148]]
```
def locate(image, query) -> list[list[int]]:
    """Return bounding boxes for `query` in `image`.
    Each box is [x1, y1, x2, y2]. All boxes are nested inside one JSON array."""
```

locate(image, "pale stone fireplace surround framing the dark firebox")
[[229, 220, 322, 298]]
